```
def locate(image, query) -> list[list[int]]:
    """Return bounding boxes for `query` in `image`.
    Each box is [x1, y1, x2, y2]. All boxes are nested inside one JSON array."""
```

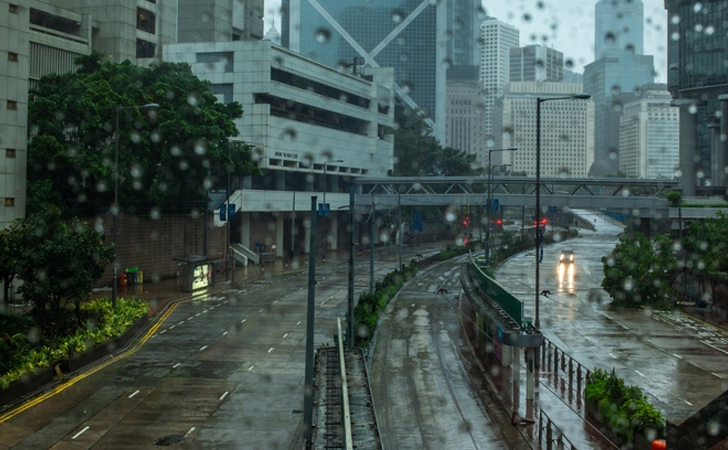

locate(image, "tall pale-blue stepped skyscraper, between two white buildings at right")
[[584, 0, 655, 176]]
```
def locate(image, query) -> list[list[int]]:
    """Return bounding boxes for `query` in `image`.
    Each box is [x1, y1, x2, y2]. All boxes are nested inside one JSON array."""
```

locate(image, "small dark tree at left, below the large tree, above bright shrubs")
[[10, 210, 114, 328]]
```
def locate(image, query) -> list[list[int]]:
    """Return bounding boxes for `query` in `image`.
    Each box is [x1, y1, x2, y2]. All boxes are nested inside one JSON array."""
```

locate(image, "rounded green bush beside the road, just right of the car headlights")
[[602, 233, 677, 307]]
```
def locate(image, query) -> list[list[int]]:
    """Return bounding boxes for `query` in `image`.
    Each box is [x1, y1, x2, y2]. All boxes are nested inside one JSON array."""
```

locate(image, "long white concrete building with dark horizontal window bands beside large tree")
[[165, 41, 394, 257]]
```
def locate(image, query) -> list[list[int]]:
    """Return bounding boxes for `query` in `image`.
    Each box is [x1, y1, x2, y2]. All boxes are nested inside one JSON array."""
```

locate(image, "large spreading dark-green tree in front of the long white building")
[[28, 53, 259, 216]]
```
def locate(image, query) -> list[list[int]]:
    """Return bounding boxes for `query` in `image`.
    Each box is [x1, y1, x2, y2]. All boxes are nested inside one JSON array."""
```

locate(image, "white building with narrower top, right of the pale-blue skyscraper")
[[619, 90, 680, 179]]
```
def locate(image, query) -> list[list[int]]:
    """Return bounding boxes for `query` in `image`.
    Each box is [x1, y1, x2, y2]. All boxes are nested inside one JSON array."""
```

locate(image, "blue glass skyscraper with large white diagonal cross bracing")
[[281, 0, 480, 142]]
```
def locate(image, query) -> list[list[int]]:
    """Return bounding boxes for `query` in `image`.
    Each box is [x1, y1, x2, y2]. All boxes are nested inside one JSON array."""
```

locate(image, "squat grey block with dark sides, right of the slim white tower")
[[508, 45, 564, 82]]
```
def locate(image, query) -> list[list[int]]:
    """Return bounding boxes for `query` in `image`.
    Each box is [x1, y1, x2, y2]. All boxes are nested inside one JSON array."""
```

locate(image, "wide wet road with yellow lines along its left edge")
[[0, 247, 432, 450]]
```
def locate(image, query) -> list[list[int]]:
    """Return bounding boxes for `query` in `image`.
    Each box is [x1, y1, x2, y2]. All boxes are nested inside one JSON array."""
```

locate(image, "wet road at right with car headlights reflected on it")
[[495, 212, 728, 424]]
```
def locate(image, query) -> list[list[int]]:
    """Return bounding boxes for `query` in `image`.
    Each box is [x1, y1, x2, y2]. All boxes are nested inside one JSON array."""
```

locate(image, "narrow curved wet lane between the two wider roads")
[[371, 258, 528, 450]]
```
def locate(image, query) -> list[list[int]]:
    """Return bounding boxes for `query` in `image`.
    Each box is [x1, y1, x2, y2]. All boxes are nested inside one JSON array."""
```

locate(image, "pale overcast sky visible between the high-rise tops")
[[264, 0, 667, 83]]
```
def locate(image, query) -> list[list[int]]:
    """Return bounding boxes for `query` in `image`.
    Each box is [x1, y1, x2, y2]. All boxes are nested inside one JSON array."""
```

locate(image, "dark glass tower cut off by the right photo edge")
[[665, 0, 728, 196]]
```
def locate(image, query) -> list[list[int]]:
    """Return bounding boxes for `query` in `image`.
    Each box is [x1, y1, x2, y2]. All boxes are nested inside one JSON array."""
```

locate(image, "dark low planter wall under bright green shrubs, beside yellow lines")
[[0, 316, 149, 410]]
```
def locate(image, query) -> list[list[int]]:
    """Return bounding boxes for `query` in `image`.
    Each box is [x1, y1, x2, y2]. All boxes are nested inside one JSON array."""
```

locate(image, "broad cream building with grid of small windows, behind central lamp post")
[[493, 82, 594, 178]]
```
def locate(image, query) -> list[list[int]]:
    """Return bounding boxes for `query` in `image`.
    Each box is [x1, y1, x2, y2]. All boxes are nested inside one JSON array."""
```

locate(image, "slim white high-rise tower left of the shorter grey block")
[[479, 17, 519, 149]]
